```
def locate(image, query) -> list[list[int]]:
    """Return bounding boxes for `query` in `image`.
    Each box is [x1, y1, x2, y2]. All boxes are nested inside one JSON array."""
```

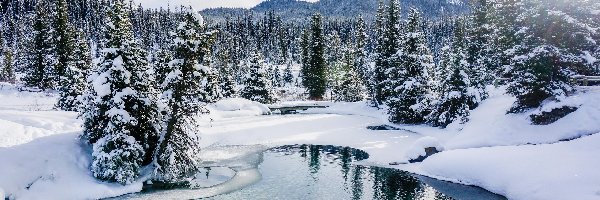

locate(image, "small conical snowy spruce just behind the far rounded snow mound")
[[240, 48, 275, 104]]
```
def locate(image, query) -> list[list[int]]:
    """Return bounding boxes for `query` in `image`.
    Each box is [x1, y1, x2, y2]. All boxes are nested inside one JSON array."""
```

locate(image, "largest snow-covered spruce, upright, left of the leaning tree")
[[81, 0, 158, 184]]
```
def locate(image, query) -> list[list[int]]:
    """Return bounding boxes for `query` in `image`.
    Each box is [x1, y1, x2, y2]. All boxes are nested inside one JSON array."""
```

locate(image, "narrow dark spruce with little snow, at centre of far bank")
[[302, 14, 327, 100]]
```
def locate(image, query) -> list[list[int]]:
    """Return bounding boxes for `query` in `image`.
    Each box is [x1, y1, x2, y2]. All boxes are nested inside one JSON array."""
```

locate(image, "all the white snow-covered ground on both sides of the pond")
[[0, 85, 600, 199]]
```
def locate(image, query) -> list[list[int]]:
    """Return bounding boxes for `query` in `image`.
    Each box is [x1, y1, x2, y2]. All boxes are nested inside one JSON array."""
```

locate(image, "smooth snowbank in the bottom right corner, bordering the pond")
[[420, 134, 600, 200]]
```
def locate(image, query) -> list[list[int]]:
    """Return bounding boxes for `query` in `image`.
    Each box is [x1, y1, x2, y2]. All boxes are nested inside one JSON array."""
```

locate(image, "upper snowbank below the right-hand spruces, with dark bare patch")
[[445, 87, 600, 149]]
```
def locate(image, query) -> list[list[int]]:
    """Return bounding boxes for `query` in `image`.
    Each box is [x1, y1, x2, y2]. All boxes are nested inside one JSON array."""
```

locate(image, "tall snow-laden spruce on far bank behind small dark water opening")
[[387, 9, 434, 124]]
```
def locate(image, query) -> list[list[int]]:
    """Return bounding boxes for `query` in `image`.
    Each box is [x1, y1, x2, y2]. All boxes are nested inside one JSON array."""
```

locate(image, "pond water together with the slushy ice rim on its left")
[[121, 145, 506, 200]]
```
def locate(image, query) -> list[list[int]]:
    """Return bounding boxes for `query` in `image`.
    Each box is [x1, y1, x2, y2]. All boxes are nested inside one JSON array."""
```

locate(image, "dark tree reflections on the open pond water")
[[272, 145, 450, 200]]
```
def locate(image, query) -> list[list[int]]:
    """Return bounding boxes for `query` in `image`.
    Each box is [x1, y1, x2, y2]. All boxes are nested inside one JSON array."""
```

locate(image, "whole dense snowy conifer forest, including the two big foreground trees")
[[0, 0, 600, 184]]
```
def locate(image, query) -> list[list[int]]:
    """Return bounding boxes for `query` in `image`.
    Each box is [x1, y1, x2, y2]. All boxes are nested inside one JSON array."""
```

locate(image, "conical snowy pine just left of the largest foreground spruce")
[[56, 32, 92, 111]]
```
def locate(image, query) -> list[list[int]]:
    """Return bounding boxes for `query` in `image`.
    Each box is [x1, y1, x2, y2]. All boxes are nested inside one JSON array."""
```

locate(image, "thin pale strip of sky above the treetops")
[[134, 0, 318, 10]]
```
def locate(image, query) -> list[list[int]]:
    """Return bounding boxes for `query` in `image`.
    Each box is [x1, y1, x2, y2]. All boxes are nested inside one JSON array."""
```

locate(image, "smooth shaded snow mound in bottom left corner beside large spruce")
[[0, 134, 142, 199]]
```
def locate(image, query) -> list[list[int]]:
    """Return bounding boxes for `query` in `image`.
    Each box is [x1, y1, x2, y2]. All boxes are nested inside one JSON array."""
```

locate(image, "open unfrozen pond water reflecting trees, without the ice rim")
[[210, 145, 505, 200]]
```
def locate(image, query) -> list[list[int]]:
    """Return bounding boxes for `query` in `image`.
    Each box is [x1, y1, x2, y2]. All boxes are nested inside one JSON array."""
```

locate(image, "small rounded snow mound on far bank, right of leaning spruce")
[[208, 98, 271, 118]]
